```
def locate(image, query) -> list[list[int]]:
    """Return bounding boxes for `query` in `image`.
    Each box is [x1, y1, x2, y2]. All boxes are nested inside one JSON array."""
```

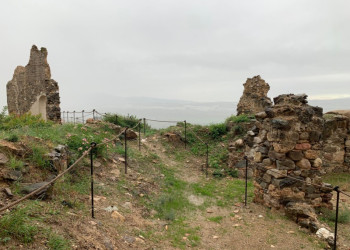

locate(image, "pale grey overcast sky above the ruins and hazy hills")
[[0, 0, 350, 110]]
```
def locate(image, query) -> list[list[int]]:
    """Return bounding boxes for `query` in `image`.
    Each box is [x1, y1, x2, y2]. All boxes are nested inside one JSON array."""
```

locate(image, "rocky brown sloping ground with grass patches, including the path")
[[1, 134, 350, 249]]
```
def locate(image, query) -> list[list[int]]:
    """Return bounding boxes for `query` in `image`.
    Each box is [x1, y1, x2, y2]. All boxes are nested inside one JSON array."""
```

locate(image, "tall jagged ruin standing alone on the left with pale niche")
[[7, 45, 61, 122]]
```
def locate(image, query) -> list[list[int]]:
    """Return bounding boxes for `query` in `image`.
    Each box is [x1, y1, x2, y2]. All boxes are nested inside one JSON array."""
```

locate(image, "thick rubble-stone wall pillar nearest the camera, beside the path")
[[250, 94, 332, 227]]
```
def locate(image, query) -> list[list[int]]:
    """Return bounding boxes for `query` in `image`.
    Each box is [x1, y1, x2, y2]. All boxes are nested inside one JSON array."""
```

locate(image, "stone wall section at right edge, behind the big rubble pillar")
[[322, 114, 350, 173]]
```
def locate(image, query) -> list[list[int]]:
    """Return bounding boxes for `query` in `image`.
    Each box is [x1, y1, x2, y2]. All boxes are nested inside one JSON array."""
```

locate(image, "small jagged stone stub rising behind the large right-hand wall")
[[237, 76, 272, 115]]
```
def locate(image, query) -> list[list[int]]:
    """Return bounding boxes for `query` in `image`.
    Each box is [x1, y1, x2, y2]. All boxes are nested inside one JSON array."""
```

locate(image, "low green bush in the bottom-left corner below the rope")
[[0, 208, 38, 243]]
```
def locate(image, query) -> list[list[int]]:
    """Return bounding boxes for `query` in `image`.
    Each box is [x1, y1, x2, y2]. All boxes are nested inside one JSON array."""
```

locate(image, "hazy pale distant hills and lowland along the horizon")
[[62, 94, 350, 128]]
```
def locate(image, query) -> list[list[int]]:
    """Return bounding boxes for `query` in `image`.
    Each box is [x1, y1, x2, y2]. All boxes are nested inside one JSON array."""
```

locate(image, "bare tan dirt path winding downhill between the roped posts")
[[138, 136, 326, 249]]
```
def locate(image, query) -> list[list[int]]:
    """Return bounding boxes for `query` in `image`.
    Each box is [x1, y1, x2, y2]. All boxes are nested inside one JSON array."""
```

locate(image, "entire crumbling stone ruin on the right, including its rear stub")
[[229, 76, 350, 232]]
